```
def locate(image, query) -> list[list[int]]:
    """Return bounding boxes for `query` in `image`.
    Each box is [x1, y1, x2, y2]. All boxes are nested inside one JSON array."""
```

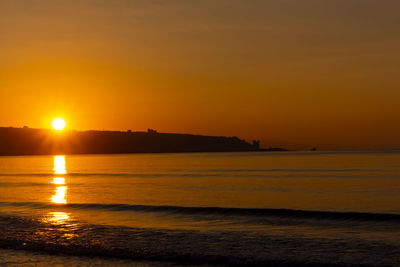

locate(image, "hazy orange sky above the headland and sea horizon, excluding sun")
[[0, 0, 400, 150]]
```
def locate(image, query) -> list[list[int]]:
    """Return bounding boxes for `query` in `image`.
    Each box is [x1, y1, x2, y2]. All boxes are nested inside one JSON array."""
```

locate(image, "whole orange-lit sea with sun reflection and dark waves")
[[0, 151, 400, 266]]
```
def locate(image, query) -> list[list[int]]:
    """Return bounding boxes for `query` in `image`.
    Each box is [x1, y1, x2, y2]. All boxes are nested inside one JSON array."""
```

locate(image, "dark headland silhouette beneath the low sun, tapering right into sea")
[[0, 127, 284, 156]]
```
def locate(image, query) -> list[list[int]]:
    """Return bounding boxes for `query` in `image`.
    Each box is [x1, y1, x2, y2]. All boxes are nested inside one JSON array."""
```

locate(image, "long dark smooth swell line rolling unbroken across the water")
[[0, 202, 400, 223]]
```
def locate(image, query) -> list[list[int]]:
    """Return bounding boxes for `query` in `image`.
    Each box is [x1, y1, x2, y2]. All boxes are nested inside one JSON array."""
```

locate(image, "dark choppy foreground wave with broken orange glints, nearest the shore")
[[0, 211, 382, 267]]
